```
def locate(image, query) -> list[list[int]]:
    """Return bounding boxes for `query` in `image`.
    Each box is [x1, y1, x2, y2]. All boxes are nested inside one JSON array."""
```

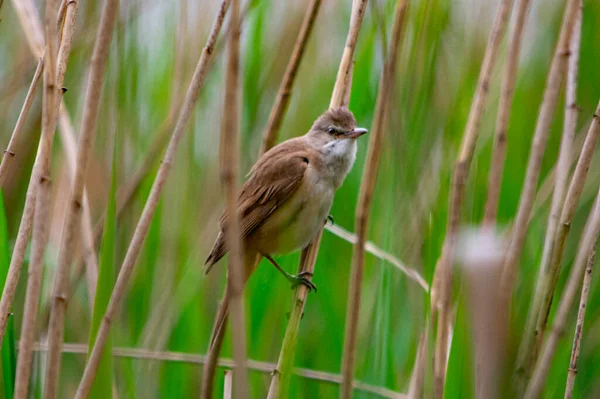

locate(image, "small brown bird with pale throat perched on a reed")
[[205, 107, 367, 341]]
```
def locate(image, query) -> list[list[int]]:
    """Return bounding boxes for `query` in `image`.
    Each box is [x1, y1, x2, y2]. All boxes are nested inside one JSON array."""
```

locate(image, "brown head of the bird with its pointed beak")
[[309, 107, 367, 143]]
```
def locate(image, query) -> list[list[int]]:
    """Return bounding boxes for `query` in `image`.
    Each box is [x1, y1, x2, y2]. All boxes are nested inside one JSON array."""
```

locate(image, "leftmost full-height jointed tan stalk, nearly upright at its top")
[[14, 0, 58, 399]]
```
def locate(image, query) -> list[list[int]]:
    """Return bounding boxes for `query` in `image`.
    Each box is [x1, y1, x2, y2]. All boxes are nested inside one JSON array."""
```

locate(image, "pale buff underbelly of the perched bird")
[[254, 183, 334, 254]]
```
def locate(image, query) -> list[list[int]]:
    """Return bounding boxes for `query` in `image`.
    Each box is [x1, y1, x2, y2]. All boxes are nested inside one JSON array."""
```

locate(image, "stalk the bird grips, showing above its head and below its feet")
[[268, 0, 368, 399]]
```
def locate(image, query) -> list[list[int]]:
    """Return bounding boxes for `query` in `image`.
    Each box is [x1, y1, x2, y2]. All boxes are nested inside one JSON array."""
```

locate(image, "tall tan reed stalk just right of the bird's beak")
[[340, 0, 408, 398]]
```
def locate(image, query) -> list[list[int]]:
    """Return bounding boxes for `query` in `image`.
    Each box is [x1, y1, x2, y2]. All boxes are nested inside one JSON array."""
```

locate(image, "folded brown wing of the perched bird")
[[221, 140, 309, 238]]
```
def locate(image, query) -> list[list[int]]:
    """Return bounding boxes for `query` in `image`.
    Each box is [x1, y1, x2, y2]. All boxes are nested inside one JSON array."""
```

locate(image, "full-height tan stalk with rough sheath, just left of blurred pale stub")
[[431, 0, 512, 398]]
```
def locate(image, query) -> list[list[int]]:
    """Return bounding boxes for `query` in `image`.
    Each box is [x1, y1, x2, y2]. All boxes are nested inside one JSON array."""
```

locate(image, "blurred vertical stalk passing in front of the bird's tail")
[[220, 0, 248, 398]]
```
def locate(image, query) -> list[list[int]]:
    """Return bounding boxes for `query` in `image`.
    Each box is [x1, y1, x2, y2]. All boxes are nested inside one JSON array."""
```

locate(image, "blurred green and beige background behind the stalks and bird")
[[0, 0, 600, 398]]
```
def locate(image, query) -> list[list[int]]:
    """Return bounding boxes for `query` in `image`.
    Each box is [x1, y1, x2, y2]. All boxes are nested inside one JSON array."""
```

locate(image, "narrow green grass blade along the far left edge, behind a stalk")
[[0, 192, 16, 398]]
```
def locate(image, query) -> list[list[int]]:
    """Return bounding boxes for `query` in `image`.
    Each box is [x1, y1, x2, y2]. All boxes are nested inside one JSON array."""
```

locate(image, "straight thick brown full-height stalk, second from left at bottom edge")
[[44, 0, 119, 399]]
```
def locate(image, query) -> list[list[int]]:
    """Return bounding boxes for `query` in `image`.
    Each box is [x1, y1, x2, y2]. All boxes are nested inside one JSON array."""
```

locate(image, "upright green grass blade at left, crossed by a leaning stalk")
[[89, 139, 117, 399]]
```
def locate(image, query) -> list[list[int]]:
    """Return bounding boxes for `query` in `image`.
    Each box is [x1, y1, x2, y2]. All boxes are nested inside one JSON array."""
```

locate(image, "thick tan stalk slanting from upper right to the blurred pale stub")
[[500, 0, 579, 306]]
